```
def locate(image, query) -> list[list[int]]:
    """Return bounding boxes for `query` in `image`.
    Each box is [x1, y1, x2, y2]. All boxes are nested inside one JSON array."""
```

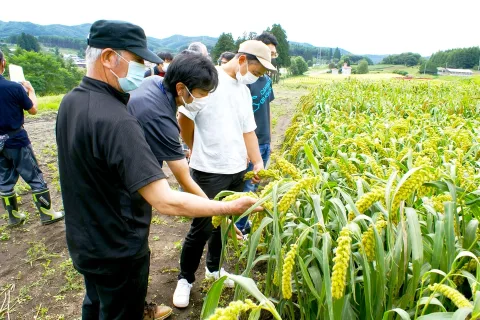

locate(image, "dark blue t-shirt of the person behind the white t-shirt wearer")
[[247, 75, 275, 144]]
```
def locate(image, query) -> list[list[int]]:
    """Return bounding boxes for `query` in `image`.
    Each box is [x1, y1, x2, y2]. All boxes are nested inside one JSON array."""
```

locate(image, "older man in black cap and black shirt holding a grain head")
[[56, 20, 261, 320]]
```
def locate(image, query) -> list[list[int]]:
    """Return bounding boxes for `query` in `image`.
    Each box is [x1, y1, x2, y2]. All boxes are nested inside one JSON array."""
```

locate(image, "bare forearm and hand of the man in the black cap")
[[138, 179, 263, 218]]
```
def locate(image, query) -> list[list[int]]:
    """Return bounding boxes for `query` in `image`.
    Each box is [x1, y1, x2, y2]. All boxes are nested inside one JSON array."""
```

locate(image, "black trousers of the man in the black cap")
[[82, 254, 150, 320]]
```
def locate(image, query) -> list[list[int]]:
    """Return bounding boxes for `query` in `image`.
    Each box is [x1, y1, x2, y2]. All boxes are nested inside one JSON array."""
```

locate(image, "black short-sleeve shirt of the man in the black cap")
[[56, 77, 165, 274]]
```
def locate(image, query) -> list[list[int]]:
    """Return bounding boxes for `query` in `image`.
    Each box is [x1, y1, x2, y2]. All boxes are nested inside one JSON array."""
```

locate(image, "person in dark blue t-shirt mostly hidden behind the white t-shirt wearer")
[[236, 32, 278, 234]]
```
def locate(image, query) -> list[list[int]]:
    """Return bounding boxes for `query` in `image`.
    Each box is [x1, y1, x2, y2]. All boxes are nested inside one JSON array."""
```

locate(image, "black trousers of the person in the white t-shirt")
[[178, 169, 245, 283]]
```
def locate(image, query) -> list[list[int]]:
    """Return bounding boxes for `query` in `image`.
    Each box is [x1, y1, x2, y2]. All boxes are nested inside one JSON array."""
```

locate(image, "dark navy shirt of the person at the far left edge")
[[0, 75, 33, 149]]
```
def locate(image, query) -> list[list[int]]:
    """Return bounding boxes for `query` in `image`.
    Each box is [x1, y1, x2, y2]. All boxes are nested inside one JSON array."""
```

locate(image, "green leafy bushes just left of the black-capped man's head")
[[1, 46, 85, 96]]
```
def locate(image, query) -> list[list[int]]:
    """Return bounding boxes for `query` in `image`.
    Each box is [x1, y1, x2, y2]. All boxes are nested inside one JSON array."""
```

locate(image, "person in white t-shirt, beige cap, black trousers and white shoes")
[[173, 40, 276, 308]]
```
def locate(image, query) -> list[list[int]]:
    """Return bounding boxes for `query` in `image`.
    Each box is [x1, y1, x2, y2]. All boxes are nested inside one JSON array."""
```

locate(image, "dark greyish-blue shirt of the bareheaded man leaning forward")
[[127, 76, 185, 164]]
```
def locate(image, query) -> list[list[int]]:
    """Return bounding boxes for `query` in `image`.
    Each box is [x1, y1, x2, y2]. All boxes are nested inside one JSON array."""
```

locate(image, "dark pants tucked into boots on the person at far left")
[[0, 144, 47, 193]]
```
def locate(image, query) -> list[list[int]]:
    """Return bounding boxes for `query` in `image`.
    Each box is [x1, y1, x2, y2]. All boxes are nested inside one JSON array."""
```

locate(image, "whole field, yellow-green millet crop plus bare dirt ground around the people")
[[0, 74, 480, 320]]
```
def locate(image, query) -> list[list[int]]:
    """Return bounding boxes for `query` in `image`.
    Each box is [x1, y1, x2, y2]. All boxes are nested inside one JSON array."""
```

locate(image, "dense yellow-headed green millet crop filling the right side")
[[203, 80, 480, 319]]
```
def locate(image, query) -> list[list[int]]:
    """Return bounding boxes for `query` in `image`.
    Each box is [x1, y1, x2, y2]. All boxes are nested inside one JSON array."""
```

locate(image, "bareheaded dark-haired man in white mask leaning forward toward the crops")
[[127, 50, 238, 224]]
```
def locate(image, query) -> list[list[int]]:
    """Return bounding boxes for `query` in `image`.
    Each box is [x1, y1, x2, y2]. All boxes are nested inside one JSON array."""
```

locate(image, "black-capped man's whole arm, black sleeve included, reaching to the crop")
[[107, 117, 261, 217]]
